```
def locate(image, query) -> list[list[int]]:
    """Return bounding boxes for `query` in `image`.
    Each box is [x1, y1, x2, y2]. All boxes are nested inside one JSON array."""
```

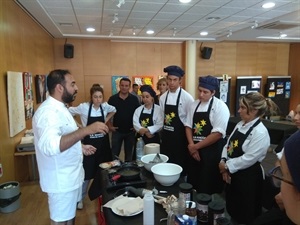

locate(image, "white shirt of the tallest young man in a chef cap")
[[159, 88, 194, 124]]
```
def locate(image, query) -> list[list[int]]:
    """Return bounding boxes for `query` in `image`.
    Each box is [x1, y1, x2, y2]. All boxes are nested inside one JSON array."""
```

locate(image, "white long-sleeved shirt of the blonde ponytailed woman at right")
[[222, 118, 270, 173]]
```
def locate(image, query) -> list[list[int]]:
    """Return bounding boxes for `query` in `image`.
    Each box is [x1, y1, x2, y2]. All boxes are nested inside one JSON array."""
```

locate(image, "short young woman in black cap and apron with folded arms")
[[133, 85, 163, 144]]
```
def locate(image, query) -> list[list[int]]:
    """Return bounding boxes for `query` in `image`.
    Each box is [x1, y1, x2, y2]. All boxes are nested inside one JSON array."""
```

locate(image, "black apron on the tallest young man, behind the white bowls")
[[160, 88, 188, 175]]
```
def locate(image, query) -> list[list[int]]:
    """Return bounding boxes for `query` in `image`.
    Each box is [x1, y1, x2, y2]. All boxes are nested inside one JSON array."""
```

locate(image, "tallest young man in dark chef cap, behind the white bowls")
[[159, 66, 194, 174]]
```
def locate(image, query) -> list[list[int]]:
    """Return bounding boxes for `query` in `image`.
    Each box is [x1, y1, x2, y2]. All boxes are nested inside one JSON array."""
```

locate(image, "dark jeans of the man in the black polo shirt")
[[111, 131, 135, 161]]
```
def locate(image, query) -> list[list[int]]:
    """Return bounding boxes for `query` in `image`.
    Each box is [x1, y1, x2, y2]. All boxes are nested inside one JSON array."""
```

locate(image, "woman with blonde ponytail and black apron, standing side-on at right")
[[219, 92, 278, 224]]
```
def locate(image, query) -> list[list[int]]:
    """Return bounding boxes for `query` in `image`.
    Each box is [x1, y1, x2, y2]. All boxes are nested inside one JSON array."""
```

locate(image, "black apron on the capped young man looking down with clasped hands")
[[187, 98, 224, 194]]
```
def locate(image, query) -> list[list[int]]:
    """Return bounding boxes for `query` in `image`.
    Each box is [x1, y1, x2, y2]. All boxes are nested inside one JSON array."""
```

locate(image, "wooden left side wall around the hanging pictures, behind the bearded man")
[[0, 1, 54, 183]]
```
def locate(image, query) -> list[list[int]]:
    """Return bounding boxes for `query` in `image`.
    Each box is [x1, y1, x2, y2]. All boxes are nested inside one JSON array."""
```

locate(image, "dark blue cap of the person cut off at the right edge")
[[284, 130, 300, 192]]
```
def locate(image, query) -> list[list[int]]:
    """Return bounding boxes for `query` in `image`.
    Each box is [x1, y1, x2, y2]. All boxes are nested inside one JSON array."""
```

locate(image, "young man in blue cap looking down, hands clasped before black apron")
[[185, 76, 230, 194]]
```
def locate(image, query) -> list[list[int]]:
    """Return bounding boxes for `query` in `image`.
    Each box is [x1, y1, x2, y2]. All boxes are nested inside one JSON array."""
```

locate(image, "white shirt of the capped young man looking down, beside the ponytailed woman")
[[184, 96, 230, 138]]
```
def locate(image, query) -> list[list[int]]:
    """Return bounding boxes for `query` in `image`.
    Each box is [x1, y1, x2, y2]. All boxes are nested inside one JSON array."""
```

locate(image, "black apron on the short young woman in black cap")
[[137, 104, 160, 145]]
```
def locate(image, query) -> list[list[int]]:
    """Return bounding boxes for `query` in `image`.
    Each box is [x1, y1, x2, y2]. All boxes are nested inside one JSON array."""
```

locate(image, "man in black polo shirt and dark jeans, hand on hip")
[[108, 77, 140, 161]]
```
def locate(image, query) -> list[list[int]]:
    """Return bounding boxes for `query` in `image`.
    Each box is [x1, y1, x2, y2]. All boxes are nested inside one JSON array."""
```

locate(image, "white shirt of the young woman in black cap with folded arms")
[[133, 104, 164, 134]]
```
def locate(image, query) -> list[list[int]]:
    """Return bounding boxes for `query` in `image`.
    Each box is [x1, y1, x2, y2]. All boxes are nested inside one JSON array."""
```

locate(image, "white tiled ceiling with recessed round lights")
[[15, 0, 300, 42]]
